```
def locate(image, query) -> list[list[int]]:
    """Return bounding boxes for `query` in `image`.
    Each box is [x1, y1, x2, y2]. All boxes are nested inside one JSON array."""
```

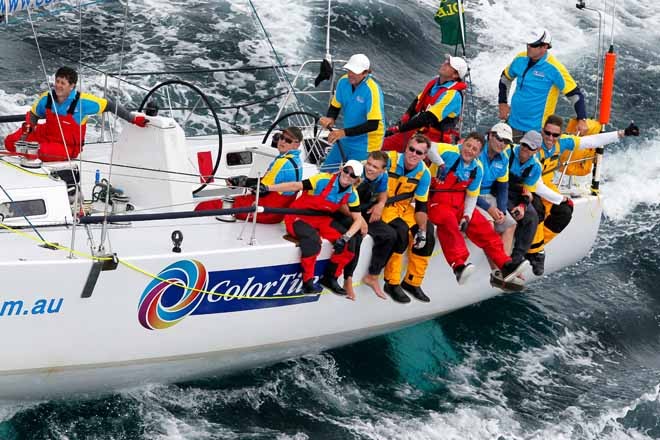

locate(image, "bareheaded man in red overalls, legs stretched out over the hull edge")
[[429, 132, 529, 285]]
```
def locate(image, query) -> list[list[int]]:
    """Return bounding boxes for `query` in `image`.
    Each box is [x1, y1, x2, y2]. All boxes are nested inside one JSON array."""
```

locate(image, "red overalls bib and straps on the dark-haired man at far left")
[[39, 90, 87, 151]]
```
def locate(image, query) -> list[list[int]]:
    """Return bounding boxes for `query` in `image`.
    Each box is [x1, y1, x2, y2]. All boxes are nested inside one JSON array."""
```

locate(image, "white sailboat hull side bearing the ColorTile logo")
[[0, 196, 601, 400]]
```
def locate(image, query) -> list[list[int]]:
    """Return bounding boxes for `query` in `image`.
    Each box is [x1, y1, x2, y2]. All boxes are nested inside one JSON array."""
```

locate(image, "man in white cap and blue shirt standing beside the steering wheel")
[[319, 53, 385, 171]]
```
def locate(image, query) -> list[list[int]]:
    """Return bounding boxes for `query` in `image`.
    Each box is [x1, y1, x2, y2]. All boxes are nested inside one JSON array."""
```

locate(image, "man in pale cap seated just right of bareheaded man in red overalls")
[[477, 122, 516, 251]]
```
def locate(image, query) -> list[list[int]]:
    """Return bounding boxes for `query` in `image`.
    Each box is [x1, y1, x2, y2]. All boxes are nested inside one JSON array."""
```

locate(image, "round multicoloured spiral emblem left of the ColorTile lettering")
[[138, 260, 208, 330]]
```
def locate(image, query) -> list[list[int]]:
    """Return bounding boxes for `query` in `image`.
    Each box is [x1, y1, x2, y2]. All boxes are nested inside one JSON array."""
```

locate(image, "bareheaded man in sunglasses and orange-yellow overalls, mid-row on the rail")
[[382, 134, 435, 303]]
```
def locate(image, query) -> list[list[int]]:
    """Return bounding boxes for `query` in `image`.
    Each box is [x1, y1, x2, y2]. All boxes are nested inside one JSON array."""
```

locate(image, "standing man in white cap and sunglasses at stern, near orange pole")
[[498, 29, 587, 142]]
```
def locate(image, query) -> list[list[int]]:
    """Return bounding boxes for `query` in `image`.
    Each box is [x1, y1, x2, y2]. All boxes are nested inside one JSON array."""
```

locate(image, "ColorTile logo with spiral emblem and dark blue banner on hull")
[[138, 260, 326, 330]]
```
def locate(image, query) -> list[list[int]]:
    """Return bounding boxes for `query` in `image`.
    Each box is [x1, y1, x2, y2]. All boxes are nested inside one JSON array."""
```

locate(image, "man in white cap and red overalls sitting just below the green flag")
[[382, 55, 468, 152]]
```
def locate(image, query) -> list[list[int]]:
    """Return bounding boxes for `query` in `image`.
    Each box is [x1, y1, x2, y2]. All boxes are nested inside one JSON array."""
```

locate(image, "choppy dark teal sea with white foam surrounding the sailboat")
[[0, 0, 660, 440]]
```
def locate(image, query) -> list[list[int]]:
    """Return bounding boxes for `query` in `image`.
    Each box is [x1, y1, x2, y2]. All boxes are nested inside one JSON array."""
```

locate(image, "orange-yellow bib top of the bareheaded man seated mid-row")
[[382, 151, 425, 223]]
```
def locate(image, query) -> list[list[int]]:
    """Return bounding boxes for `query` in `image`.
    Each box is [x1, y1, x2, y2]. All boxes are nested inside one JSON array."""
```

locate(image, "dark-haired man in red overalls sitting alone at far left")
[[5, 67, 148, 162]]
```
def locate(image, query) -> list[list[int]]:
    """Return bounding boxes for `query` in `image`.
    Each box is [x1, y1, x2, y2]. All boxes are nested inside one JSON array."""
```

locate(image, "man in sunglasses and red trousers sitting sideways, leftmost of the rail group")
[[195, 126, 303, 223]]
